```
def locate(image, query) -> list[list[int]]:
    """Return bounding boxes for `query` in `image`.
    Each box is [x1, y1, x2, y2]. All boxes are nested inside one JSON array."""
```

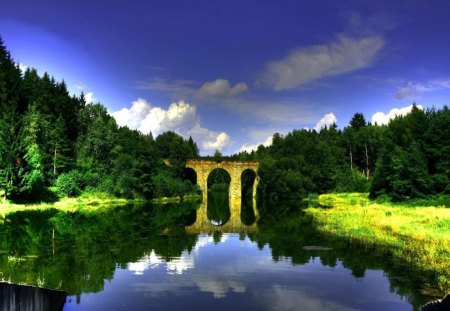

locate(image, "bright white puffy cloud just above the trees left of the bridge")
[[111, 98, 231, 152]]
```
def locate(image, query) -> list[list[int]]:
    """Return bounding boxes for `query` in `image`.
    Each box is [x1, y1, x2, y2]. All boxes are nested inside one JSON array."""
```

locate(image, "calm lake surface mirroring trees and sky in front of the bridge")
[[0, 198, 440, 310]]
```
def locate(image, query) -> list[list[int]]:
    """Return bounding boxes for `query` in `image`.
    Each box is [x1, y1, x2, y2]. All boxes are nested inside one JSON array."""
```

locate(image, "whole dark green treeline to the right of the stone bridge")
[[236, 105, 450, 201]]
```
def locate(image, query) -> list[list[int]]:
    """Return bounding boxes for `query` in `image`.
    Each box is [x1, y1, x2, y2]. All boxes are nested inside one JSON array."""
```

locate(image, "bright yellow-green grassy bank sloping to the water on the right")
[[306, 193, 450, 292]]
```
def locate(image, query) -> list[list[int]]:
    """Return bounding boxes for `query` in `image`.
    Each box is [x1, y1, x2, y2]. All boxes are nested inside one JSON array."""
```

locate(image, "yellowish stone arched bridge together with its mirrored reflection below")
[[185, 160, 259, 233]]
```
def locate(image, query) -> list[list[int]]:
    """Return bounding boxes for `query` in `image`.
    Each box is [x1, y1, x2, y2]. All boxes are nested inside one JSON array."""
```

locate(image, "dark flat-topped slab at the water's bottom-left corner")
[[0, 282, 67, 311]]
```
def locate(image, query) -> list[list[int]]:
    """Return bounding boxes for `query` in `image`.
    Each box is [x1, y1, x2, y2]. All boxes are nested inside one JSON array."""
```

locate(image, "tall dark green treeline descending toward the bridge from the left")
[[0, 38, 198, 200]]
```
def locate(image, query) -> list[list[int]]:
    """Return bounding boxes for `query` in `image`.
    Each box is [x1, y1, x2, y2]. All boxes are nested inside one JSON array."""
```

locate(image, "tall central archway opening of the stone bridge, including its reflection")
[[206, 168, 231, 226]]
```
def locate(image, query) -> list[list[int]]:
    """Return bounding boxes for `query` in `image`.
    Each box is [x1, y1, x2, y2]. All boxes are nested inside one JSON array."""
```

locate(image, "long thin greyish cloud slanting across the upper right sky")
[[261, 35, 384, 91]]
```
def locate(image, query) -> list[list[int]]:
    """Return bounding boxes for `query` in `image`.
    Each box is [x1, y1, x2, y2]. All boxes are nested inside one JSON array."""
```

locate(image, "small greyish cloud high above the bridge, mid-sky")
[[197, 79, 248, 98]]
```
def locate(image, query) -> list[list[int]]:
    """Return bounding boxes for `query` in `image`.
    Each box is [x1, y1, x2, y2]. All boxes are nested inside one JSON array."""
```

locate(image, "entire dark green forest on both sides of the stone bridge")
[[0, 38, 450, 201]]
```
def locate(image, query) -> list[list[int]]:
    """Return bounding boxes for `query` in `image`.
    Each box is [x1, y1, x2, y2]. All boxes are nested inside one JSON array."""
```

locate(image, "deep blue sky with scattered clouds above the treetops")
[[0, 0, 450, 154]]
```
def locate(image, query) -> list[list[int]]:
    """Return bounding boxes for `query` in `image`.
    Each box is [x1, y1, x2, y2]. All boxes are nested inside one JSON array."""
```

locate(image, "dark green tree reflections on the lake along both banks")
[[0, 202, 442, 308]]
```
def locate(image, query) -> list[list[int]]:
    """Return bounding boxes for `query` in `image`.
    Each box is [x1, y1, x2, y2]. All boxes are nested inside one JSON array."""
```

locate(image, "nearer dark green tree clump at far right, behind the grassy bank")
[[370, 106, 450, 201]]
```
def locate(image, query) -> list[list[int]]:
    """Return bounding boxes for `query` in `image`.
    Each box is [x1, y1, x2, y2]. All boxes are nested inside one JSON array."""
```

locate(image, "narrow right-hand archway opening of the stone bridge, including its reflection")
[[241, 169, 256, 226]]
